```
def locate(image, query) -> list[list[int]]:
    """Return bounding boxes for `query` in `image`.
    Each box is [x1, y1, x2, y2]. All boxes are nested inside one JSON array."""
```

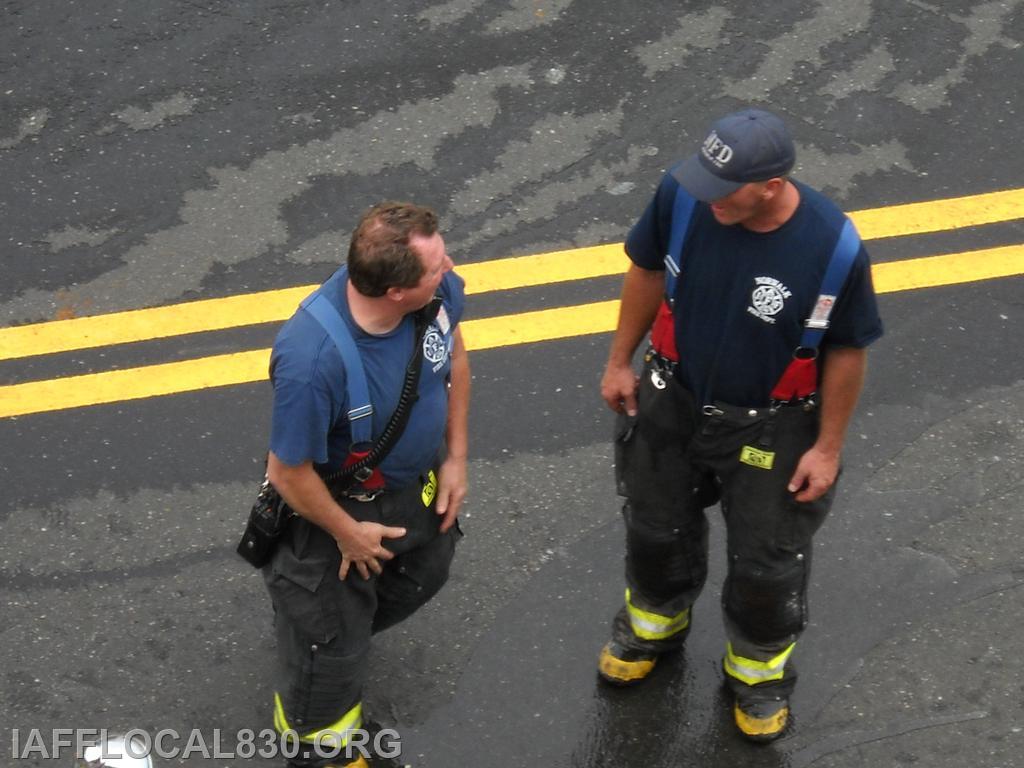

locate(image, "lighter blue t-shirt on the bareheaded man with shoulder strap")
[[270, 267, 466, 487]]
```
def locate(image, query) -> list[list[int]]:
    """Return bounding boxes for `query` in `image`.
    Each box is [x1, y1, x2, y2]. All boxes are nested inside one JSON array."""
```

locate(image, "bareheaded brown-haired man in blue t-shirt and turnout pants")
[[263, 203, 470, 768]]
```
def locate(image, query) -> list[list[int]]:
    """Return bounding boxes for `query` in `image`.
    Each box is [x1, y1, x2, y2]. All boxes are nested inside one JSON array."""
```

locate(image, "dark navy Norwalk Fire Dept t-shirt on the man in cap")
[[626, 171, 882, 408]]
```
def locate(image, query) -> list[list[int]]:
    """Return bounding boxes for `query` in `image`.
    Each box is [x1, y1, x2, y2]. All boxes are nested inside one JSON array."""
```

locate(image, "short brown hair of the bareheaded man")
[[348, 201, 437, 297]]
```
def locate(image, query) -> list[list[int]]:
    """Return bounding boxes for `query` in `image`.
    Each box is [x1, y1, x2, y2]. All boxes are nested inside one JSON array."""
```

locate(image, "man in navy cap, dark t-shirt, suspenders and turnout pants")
[[598, 109, 882, 741]]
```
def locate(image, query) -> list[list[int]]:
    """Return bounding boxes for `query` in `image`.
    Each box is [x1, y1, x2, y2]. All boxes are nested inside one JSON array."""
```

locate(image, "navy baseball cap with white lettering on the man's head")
[[673, 110, 797, 203]]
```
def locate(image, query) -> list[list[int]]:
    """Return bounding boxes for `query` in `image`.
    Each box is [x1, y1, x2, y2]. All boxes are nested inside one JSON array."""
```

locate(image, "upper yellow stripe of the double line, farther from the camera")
[[0, 189, 1024, 360]]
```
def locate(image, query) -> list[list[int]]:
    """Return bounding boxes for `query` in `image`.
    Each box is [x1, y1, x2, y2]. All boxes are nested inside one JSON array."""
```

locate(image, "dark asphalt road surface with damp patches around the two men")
[[0, 0, 1024, 768]]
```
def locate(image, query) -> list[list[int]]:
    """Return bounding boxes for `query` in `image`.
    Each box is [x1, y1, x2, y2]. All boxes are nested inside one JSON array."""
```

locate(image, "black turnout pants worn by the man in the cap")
[[613, 361, 835, 696]]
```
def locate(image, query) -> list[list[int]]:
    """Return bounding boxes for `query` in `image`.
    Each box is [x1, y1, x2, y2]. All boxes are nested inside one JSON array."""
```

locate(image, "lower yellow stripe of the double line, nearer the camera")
[[0, 245, 1024, 418]]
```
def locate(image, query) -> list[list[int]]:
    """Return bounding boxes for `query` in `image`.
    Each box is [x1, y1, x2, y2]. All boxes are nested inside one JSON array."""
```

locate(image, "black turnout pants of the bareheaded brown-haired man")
[[263, 476, 461, 766]]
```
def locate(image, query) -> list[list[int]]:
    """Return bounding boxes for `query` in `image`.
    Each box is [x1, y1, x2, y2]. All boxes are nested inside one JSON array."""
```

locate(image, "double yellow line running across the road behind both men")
[[0, 189, 1024, 418]]
